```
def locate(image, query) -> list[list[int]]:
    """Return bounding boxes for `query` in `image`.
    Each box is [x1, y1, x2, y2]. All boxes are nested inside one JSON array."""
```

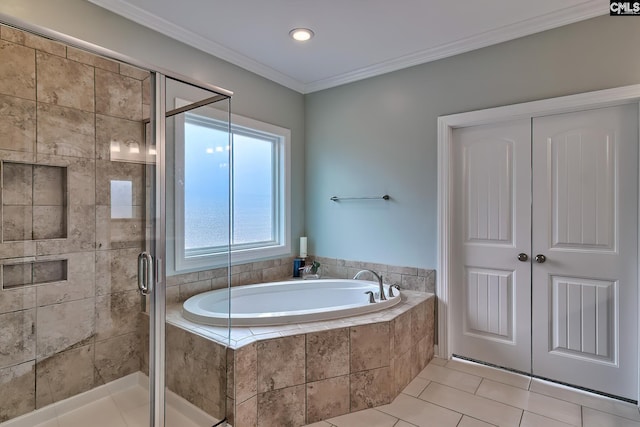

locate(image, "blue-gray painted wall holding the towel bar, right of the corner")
[[305, 16, 640, 268]]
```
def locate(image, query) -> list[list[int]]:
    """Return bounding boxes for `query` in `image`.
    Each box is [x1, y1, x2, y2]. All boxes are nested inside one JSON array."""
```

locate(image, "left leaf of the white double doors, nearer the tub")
[[451, 120, 531, 372]]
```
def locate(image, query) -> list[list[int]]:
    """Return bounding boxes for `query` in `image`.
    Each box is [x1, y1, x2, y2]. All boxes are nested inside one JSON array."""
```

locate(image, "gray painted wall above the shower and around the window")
[[0, 0, 304, 260]]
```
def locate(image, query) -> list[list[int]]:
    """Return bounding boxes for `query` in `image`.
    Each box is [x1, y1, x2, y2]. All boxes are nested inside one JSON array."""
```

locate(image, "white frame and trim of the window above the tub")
[[172, 98, 291, 274]]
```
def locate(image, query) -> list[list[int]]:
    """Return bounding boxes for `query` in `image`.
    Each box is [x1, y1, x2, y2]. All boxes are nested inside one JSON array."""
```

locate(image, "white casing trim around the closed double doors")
[[436, 85, 640, 399]]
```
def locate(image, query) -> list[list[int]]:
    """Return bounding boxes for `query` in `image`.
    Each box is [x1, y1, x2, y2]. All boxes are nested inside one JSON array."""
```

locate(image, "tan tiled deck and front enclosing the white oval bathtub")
[[160, 291, 435, 427]]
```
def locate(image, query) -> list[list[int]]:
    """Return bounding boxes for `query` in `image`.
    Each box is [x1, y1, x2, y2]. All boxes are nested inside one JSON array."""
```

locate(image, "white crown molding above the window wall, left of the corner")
[[89, 0, 305, 93]]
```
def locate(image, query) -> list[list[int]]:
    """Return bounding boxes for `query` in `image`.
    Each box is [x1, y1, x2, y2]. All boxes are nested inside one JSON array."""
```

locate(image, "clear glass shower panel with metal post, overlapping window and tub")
[[145, 73, 231, 427]]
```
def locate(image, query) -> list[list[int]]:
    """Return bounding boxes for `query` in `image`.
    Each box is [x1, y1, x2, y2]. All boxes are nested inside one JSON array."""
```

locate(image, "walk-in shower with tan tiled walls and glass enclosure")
[[0, 17, 231, 426]]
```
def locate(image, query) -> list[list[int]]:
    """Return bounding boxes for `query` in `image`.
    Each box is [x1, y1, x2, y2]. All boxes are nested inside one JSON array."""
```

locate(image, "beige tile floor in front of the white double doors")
[[307, 359, 640, 427]]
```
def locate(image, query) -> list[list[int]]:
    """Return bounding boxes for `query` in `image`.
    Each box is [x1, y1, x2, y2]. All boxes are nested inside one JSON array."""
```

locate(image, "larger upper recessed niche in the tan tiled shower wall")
[[1, 162, 67, 242]]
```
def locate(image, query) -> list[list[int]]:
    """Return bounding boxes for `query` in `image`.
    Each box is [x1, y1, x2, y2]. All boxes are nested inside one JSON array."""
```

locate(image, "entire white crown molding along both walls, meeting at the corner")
[[89, 0, 609, 94]]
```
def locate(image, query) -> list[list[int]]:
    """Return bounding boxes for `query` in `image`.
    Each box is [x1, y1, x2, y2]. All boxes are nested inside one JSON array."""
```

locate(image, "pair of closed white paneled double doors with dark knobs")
[[450, 104, 638, 400]]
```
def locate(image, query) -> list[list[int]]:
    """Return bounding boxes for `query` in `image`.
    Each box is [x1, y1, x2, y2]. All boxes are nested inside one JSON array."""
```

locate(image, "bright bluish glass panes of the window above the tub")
[[184, 120, 275, 251]]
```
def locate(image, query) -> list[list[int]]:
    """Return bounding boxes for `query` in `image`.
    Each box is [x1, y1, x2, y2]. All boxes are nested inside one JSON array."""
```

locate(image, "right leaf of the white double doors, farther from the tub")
[[532, 104, 638, 400]]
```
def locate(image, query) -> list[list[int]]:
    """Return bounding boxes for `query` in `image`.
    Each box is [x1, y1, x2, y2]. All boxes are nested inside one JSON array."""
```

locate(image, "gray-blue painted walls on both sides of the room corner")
[[5, 0, 640, 268]]
